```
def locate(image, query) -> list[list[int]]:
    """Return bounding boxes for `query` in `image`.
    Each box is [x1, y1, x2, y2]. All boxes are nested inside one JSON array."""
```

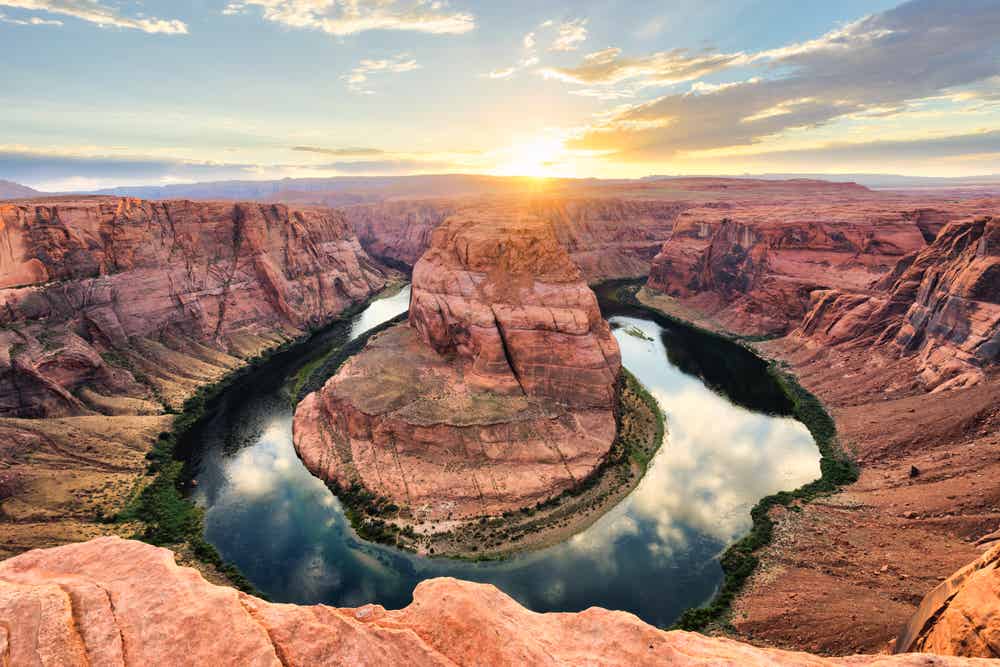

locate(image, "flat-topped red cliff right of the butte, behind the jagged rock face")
[[648, 193, 992, 334]]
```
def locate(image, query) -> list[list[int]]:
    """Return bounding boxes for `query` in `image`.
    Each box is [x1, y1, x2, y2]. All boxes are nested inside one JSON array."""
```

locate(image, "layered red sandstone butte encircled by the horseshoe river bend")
[[294, 207, 621, 520]]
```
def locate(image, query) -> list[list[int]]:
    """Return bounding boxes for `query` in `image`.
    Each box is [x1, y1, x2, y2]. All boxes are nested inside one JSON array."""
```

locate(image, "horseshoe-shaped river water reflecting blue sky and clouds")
[[188, 290, 819, 625]]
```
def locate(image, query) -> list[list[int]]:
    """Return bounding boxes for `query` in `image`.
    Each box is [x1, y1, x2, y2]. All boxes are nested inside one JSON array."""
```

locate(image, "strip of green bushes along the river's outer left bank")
[[106, 290, 400, 596]]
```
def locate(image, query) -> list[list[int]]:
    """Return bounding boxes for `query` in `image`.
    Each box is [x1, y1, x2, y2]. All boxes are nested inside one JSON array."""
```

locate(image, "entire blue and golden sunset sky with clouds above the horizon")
[[0, 0, 1000, 190]]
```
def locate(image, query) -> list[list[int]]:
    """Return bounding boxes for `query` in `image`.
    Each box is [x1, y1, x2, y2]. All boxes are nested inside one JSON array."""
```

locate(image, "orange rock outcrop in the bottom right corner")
[[896, 547, 1000, 658]]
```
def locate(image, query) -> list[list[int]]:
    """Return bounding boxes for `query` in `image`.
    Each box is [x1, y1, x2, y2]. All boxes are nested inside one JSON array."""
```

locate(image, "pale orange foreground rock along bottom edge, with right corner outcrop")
[[0, 537, 1000, 667]]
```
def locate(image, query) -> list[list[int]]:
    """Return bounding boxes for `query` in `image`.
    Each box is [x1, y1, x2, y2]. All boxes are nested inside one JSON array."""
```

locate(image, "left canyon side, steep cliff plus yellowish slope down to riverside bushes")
[[0, 197, 390, 555]]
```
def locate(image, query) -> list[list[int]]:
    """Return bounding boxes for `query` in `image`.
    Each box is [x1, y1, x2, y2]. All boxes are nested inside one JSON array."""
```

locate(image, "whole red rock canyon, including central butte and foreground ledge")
[[0, 179, 1000, 665]]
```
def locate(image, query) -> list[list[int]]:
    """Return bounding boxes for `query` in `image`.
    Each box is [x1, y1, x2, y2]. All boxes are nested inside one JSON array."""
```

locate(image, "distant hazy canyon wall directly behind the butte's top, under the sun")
[[344, 195, 687, 282]]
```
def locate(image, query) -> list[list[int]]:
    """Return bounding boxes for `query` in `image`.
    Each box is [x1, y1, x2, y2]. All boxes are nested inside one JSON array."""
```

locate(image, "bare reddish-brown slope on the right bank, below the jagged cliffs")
[[638, 282, 1000, 655]]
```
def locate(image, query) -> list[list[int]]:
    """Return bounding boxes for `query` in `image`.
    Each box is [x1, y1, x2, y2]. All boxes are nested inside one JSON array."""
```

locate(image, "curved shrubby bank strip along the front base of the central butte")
[[330, 368, 666, 561]]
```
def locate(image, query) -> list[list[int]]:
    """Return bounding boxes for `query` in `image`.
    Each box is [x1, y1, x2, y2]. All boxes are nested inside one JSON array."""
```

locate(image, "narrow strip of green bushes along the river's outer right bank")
[[608, 281, 859, 631]]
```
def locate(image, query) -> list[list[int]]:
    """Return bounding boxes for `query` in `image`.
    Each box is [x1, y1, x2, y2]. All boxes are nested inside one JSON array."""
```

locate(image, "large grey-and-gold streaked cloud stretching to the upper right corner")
[[568, 0, 1000, 159]]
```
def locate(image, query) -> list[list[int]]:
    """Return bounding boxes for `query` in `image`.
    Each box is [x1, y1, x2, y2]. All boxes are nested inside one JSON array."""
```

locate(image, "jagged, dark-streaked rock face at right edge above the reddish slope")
[[794, 217, 1000, 389]]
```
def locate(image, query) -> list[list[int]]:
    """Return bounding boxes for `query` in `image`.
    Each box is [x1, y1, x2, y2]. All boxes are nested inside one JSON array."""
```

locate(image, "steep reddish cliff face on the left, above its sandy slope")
[[0, 198, 385, 417]]
